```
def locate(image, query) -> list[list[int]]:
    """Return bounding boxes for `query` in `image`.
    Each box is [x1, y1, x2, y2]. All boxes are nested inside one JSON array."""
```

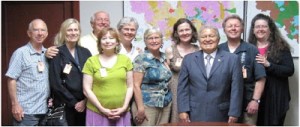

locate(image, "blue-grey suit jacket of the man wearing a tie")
[[177, 50, 243, 122]]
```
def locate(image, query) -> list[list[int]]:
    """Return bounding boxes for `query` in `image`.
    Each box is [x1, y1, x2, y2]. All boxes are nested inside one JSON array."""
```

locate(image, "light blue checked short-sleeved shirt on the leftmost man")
[[5, 42, 50, 114]]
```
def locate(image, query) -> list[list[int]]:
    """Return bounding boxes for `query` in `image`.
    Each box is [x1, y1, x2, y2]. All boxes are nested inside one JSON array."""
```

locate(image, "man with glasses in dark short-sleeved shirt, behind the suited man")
[[219, 15, 266, 125]]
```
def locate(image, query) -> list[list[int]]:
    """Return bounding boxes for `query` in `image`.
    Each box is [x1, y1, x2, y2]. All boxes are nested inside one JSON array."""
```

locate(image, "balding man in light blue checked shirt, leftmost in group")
[[5, 19, 50, 126]]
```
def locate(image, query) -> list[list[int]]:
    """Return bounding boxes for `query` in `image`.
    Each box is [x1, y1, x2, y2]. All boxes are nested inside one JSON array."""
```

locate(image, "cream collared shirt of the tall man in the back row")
[[79, 32, 99, 56]]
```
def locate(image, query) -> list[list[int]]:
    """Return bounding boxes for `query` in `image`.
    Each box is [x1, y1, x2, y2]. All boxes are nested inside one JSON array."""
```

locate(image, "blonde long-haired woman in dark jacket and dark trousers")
[[49, 18, 91, 126]]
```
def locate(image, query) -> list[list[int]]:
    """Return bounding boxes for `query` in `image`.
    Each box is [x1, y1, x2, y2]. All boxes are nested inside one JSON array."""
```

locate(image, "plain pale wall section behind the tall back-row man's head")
[[79, 1, 123, 36]]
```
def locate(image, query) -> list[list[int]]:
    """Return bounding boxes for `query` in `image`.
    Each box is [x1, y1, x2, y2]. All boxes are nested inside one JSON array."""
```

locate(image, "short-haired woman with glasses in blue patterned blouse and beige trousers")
[[132, 28, 172, 126]]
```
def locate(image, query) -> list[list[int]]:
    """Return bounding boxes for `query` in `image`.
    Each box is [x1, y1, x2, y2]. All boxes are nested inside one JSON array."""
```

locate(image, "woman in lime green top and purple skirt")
[[82, 28, 133, 126]]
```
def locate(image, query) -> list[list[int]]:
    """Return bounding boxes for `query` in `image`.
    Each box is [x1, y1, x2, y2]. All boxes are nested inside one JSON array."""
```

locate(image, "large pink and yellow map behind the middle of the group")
[[124, 1, 244, 51]]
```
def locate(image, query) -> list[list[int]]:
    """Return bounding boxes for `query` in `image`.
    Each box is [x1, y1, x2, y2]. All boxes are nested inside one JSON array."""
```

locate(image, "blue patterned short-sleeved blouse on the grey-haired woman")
[[133, 50, 172, 107]]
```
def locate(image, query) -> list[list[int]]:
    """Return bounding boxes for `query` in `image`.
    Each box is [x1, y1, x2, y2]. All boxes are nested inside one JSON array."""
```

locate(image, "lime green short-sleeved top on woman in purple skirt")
[[82, 54, 133, 114]]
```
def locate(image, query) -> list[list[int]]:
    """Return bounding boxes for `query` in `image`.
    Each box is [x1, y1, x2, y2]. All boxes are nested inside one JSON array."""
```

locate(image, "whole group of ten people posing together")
[[6, 11, 294, 126]]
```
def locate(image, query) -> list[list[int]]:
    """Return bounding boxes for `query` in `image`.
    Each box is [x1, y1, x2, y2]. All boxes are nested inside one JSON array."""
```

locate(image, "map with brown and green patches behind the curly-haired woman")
[[247, 1, 299, 57]]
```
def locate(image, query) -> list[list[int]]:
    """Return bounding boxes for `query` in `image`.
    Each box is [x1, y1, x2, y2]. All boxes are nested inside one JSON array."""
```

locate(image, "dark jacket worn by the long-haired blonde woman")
[[49, 45, 91, 107]]
